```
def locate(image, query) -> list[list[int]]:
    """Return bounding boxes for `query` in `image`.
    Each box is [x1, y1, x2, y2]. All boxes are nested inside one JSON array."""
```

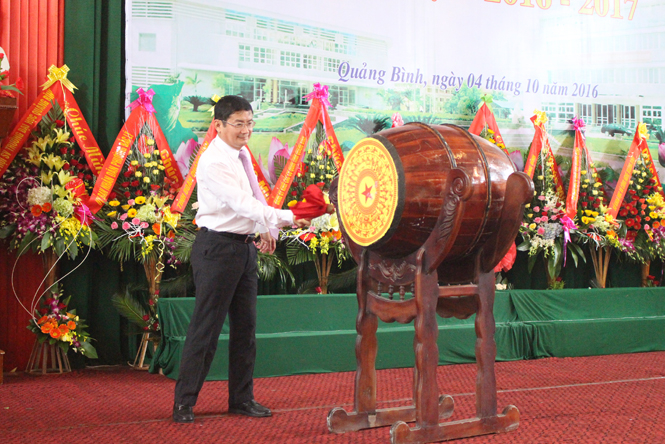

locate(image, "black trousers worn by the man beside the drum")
[[175, 229, 257, 406]]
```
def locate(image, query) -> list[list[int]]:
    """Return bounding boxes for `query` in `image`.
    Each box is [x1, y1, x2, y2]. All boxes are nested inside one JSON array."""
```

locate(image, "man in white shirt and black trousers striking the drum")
[[173, 96, 309, 422]]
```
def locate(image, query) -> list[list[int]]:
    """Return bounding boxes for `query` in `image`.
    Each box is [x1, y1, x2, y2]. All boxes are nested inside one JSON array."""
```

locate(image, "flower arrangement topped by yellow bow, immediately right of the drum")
[[517, 136, 586, 289]]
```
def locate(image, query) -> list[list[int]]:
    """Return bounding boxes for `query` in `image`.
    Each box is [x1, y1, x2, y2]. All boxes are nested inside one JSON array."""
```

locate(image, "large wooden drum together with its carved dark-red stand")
[[328, 123, 533, 443]]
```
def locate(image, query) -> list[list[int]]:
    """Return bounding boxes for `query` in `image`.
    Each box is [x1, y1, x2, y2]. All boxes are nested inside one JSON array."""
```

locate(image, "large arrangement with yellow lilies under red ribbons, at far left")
[[0, 102, 96, 259]]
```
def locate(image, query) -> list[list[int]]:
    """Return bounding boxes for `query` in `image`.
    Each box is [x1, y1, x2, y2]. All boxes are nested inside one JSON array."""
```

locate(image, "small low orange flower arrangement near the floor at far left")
[[28, 286, 97, 359]]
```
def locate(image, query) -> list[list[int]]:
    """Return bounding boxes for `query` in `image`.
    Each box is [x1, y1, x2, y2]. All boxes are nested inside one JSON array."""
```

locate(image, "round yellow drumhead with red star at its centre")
[[338, 138, 401, 247]]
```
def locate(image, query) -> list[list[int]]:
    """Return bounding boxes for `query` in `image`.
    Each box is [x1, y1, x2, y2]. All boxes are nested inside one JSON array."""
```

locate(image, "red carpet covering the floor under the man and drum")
[[0, 352, 665, 444]]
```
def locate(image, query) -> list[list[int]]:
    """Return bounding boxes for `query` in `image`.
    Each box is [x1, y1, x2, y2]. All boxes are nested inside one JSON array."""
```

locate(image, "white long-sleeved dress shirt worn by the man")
[[196, 136, 293, 234]]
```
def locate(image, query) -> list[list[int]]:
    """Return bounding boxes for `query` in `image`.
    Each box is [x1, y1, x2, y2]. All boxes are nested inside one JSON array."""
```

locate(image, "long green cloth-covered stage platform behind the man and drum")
[[151, 288, 665, 380]]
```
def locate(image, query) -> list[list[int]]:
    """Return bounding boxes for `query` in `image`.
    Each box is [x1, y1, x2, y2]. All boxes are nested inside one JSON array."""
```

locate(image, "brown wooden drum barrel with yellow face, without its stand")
[[337, 123, 515, 281]]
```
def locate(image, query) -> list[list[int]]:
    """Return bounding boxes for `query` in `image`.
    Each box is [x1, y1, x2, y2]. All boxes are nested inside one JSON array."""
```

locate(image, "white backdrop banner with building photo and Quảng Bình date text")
[[126, 0, 665, 193]]
